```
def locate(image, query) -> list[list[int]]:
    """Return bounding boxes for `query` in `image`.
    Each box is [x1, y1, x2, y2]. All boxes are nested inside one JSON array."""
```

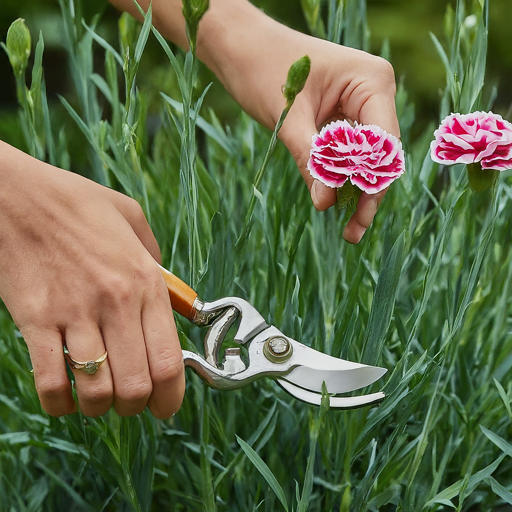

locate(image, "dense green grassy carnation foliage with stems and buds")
[[0, 0, 512, 512]]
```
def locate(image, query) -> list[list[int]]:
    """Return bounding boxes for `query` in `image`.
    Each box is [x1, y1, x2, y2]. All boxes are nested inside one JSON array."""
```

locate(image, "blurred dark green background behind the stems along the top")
[[0, 0, 512, 147]]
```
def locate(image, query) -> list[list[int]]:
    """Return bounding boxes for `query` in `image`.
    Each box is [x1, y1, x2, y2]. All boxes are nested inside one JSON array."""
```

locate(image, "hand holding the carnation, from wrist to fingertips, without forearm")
[[280, 38, 400, 243]]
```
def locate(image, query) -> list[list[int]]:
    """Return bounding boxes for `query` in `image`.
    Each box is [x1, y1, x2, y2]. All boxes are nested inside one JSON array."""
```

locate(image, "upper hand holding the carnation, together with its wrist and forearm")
[[194, 0, 400, 243]]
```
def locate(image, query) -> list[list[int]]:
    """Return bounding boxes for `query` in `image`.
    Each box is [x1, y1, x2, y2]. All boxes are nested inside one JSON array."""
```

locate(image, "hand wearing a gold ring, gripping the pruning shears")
[[0, 142, 185, 418]]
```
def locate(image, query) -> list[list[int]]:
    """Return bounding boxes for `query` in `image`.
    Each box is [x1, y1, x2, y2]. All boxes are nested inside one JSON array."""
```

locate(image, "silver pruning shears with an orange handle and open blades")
[[160, 267, 387, 409]]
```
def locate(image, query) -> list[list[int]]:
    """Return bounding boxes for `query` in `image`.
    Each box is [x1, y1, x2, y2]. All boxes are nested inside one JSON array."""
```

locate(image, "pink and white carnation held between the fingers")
[[308, 121, 405, 194]]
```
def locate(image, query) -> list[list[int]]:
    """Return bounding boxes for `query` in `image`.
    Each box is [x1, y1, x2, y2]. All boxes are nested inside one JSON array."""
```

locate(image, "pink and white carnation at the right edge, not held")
[[430, 112, 512, 171]]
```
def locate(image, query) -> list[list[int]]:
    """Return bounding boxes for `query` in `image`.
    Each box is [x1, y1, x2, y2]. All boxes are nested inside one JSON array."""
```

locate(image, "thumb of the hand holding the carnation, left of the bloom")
[[279, 102, 336, 211]]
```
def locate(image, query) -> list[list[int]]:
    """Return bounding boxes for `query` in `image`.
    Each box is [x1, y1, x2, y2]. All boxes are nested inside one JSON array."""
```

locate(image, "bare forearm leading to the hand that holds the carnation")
[[110, 0, 313, 127]]
